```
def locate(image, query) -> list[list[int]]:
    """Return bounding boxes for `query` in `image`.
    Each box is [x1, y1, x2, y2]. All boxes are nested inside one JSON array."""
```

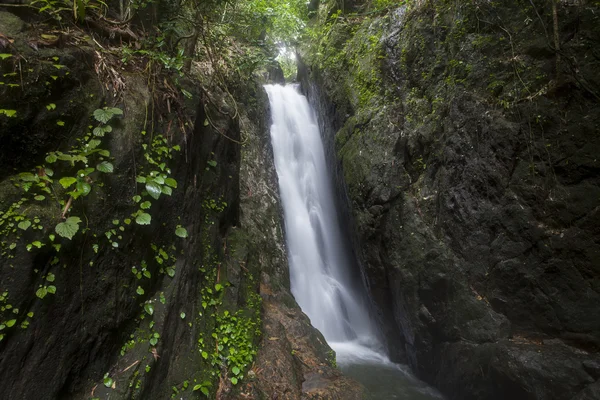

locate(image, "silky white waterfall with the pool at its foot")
[[265, 85, 439, 400]]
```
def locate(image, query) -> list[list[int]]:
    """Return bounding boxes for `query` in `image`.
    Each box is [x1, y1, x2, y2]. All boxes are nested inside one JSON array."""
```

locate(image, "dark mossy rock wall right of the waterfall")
[[300, 2, 600, 399]]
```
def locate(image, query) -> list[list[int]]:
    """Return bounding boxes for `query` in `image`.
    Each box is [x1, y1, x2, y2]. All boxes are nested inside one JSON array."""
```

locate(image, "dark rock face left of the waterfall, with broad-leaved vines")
[[0, 13, 360, 400]]
